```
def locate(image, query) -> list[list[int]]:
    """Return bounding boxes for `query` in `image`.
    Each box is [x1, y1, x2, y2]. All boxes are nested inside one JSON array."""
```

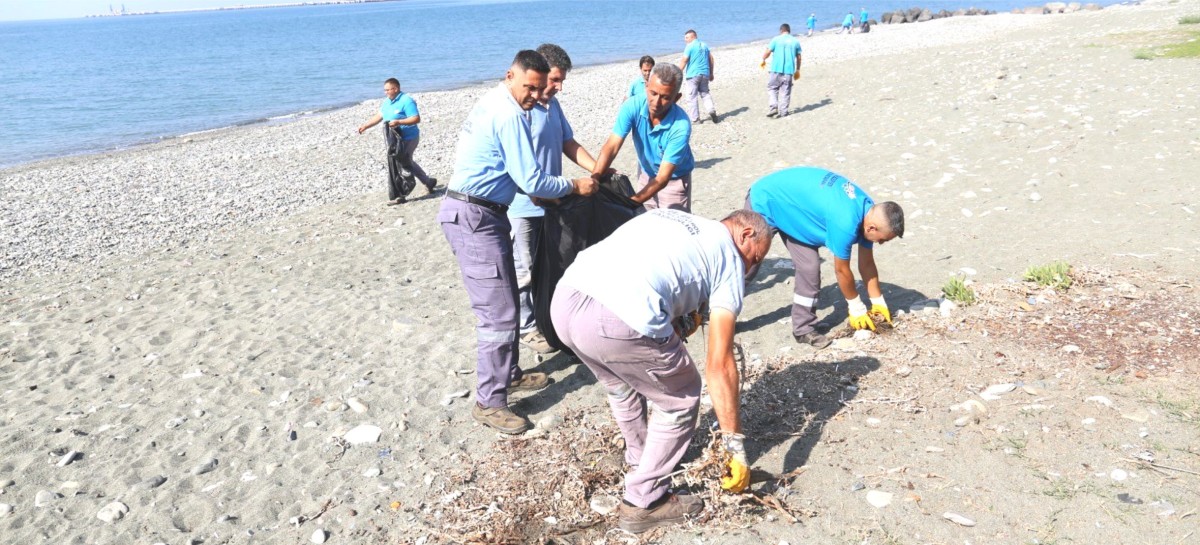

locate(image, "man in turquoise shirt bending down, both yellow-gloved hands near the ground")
[[746, 167, 904, 348]]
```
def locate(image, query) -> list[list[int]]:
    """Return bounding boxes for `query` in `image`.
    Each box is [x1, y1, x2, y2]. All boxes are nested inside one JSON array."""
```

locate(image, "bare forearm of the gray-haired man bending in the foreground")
[[704, 309, 742, 433]]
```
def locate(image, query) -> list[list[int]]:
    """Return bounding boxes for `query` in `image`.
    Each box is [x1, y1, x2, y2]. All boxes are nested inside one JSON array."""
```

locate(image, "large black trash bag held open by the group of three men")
[[532, 174, 642, 352]]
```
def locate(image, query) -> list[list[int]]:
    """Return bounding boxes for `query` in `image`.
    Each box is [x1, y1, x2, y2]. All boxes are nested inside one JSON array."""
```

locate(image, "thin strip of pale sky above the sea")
[[0, 0, 333, 20]]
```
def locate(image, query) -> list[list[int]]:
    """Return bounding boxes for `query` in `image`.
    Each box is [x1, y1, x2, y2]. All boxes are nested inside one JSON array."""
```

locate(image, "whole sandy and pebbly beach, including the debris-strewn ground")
[[0, 0, 1200, 545]]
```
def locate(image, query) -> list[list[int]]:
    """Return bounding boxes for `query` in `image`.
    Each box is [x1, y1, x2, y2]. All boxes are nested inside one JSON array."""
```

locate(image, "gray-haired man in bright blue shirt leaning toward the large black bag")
[[592, 62, 696, 212]]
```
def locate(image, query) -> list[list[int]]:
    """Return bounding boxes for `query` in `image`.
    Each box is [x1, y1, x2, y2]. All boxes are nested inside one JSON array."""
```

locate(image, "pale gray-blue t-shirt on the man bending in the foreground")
[[558, 209, 745, 339]]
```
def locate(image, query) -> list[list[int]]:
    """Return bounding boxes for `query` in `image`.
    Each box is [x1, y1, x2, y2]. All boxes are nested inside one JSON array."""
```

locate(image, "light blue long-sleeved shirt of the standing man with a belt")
[[446, 84, 575, 204]]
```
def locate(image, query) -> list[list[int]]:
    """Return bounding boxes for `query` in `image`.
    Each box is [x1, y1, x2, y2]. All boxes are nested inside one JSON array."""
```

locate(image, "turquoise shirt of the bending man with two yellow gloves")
[[750, 167, 875, 260]]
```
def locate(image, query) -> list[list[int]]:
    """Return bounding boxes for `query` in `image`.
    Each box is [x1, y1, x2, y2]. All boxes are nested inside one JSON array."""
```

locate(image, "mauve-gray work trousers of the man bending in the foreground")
[[550, 286, 701, 509]]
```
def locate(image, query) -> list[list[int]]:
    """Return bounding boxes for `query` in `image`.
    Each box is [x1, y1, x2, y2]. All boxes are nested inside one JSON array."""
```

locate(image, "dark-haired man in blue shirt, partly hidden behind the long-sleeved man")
[[509, 43, 595, 354]]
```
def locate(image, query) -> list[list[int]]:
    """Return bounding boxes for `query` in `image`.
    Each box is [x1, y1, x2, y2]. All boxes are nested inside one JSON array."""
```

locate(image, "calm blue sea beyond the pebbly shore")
[[0, 0, 1112, 166]]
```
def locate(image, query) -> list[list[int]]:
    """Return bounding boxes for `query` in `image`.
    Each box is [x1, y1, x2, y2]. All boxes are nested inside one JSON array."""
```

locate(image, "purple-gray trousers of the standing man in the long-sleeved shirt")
[[438, 198, 522, 407]]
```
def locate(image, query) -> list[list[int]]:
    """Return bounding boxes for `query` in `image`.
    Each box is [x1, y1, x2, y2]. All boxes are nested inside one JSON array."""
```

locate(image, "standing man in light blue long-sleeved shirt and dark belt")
[[437, 49, 598, 433]]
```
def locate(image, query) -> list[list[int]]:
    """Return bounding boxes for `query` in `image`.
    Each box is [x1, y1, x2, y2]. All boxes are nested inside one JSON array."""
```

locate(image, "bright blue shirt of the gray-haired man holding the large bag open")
[[612, 92, 696, 178]]
